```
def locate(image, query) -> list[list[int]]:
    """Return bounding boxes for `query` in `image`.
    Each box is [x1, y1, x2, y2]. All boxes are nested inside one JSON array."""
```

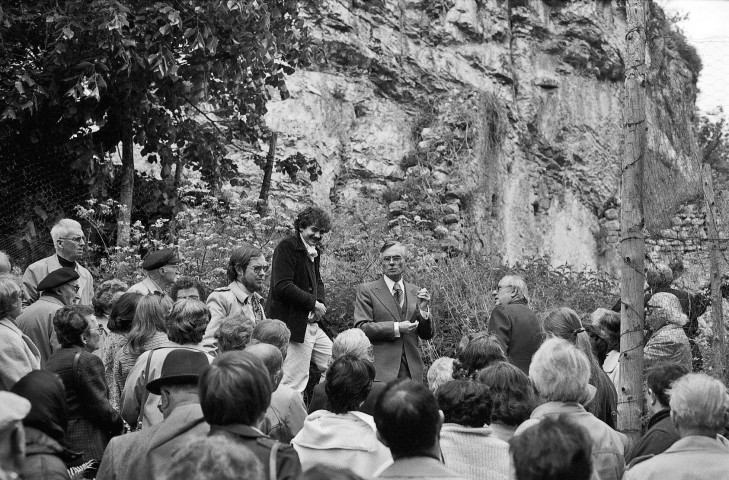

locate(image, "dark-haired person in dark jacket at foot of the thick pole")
[[625, 363, 689, 463]]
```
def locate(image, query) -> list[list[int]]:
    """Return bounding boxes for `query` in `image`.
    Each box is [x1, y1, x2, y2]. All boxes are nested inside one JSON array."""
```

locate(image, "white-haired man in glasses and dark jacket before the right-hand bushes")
[[489, 275, 542, 375]]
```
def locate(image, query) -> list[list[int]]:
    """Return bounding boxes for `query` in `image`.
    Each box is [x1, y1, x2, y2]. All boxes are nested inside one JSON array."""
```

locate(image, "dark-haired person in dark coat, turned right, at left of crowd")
[[46, 305, 123, 461]]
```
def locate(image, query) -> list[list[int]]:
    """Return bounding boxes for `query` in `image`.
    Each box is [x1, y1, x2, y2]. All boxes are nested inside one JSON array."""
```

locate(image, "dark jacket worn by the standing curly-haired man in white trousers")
[[266, 233, 324, 343]]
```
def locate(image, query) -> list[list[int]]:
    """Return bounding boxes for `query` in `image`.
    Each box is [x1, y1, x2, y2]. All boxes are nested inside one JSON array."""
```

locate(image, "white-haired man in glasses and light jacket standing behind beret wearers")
[[23, 218, 94, 307]]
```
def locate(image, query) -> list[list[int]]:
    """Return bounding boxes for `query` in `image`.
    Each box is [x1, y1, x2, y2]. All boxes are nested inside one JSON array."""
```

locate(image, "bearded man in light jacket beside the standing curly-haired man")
[[203, 244, 268, 347]]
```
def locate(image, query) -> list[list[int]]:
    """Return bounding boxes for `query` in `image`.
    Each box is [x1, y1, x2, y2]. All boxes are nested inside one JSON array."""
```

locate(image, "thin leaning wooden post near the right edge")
[[702, 163, 726, 380]]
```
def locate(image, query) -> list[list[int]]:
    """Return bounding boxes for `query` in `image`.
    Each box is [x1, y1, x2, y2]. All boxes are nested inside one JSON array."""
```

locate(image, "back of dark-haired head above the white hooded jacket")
[[324, 355, 375, 414]]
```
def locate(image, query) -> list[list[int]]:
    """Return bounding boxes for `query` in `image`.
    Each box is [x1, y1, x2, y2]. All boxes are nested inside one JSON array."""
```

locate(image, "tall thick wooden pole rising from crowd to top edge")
[[618, 0, 646, 441]]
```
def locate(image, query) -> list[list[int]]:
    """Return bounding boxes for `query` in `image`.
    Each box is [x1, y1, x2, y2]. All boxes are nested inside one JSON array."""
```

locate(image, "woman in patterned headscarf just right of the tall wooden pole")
[[643, 292, 691, 372]]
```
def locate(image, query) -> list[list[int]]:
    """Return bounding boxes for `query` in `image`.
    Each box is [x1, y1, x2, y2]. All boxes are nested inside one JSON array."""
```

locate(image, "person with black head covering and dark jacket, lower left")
[[11, 370, 81, 480]]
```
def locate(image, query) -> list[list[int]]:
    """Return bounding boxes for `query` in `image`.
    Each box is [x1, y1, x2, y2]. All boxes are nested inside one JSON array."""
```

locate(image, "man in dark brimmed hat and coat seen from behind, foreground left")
[[96, 348, 210, 480]]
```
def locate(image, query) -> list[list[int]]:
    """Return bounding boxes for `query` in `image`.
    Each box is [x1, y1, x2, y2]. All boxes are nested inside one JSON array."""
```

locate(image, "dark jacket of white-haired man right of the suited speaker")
[[489, 300, 542, 375]]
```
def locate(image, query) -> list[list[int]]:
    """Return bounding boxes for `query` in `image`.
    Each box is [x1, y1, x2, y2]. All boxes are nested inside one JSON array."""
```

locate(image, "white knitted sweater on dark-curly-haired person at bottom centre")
[[440, 423, 510, 480]]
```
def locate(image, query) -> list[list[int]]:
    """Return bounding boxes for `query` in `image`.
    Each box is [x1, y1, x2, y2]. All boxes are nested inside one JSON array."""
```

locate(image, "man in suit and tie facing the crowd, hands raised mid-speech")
[[354, 242, 433, 383]]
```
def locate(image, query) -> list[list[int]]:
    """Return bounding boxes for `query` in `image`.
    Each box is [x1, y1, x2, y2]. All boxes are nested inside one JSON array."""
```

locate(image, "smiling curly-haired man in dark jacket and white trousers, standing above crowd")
[[266, 207, 332, 392]]
